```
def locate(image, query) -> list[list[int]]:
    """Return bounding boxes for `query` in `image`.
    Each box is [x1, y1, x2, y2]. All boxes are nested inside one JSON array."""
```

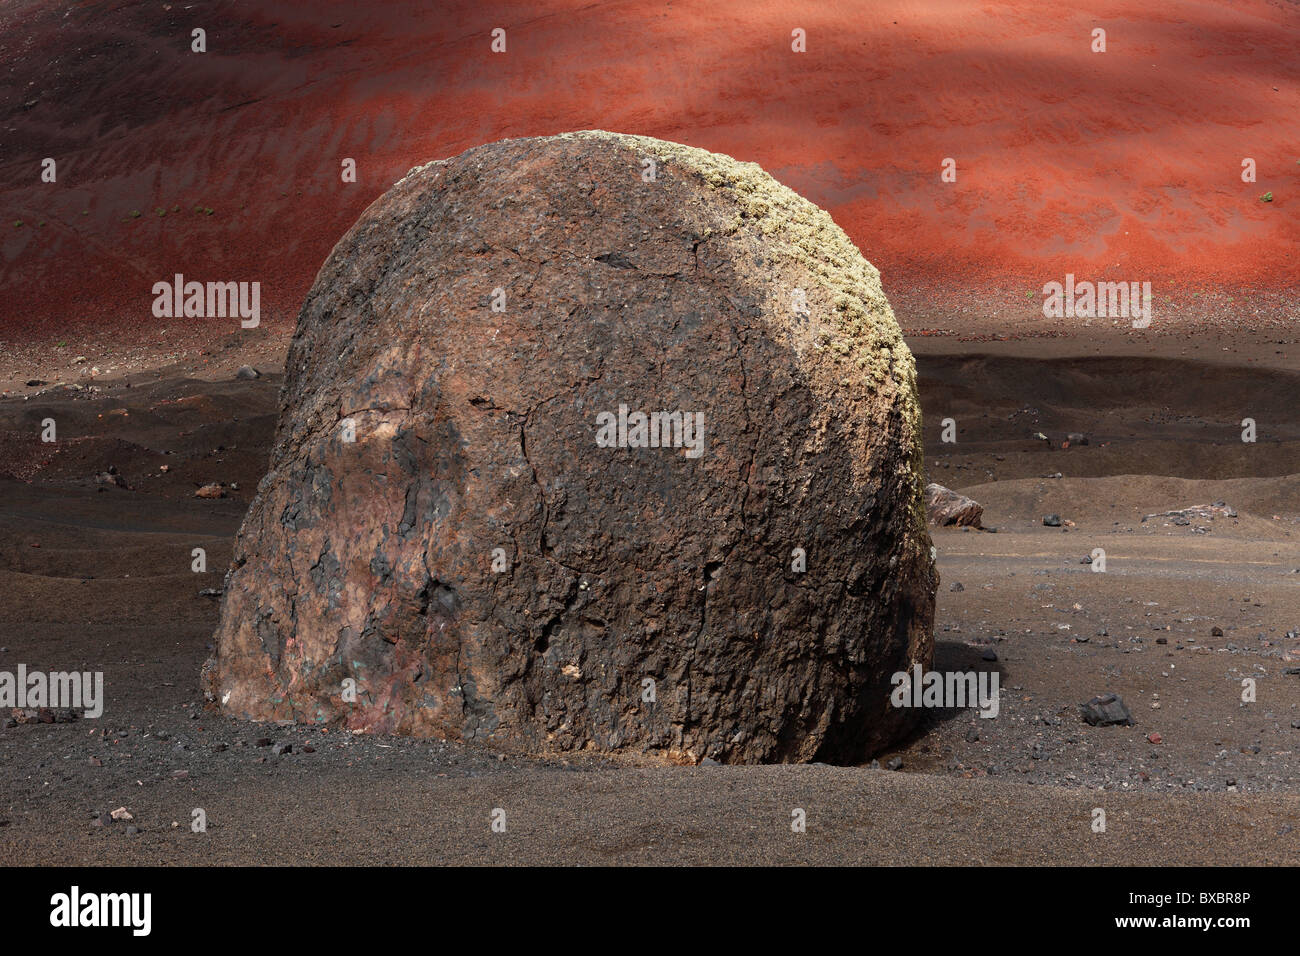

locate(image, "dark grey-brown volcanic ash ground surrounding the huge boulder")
[[0, 323, 1300, 864]]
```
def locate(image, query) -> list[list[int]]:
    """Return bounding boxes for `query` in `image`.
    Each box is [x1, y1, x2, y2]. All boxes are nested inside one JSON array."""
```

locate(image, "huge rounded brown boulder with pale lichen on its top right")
[[205, 133, 936, 762]]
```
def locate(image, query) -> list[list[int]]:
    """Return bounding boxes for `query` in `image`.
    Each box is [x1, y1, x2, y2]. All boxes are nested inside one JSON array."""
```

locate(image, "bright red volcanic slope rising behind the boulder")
[[0, 0, 1300, 337]]
